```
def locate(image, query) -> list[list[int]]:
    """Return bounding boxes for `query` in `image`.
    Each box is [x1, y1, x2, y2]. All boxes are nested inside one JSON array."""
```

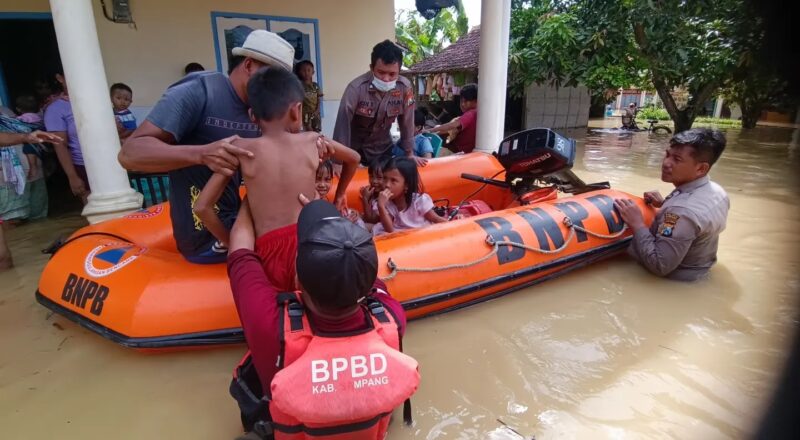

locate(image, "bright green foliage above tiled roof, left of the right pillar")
[[394, 1, 469, 66]]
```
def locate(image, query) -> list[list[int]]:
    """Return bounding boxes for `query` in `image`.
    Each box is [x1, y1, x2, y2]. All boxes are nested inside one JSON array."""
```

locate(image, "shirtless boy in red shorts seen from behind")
[[195, 67, 361, 290]]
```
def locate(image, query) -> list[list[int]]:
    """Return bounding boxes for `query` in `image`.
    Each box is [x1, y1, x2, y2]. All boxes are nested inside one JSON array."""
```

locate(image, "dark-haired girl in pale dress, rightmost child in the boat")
[[372, 157, 447, 235]]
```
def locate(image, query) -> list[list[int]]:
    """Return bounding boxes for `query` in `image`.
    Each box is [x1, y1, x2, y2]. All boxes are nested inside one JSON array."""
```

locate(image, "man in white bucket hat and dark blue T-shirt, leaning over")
[[119, 30, 294, 264]]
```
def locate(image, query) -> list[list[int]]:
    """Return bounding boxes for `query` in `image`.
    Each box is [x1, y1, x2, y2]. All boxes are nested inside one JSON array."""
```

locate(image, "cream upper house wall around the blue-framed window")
[[0, 0, 394, 131]]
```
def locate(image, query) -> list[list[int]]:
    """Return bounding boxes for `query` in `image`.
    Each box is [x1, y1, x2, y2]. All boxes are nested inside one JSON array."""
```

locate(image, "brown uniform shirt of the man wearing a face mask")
[[333, 72, 414, 163]]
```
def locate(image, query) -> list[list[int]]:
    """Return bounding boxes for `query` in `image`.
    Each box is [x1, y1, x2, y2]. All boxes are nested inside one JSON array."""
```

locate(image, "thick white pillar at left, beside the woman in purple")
[[50, 0, 142, 223]]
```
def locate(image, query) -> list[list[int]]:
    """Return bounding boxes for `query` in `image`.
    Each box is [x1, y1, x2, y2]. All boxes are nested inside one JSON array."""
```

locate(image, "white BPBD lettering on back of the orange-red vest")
[[311, 353, 389, 394]]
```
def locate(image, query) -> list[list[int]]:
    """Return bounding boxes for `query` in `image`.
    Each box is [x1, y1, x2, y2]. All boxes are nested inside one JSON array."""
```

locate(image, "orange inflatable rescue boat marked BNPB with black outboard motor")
[[36, 129, 653, 349]]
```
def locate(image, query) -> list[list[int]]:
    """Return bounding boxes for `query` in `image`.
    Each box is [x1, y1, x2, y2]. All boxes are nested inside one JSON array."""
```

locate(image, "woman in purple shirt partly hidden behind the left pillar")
[[44, 69, 91, 205]]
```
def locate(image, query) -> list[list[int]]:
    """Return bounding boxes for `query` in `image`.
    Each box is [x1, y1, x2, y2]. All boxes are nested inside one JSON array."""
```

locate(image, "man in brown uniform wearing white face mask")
[[333, 40, 427, 166]]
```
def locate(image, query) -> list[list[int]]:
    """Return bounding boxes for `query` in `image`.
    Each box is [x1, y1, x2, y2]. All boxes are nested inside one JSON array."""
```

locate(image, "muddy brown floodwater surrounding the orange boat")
[[0, 121, 800, 440]]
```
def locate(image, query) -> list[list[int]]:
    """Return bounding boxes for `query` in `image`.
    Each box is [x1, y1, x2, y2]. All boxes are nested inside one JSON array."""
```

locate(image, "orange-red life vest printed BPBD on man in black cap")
[[231, 293, 420, 440]]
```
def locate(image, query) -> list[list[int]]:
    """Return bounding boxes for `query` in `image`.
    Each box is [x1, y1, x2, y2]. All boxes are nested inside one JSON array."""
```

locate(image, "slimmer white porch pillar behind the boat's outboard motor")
[[475, 0, 511, 153]]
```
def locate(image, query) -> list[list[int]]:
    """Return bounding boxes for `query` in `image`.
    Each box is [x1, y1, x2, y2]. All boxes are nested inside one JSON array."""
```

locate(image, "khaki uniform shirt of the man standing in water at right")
[[628, 176, 730, 281]]
